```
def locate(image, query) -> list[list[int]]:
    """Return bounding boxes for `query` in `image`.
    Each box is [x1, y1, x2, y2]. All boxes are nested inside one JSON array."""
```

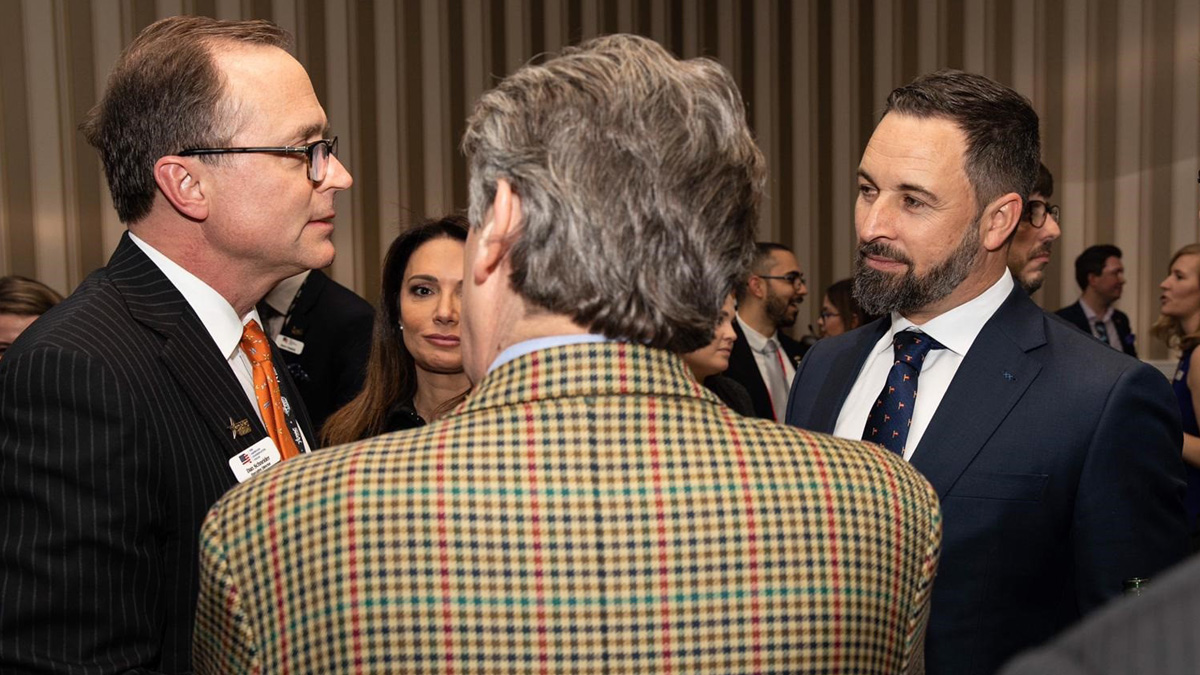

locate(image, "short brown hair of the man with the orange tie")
[[82, 17, 292, 225]]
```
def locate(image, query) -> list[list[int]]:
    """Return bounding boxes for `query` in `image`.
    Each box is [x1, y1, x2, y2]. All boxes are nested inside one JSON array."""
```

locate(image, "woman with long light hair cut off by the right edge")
[[1152, 244, 1200, 540]]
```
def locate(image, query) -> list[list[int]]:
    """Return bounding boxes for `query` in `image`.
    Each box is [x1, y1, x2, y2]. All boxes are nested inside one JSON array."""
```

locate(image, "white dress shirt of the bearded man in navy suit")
[[833, 269, 1013, 460]]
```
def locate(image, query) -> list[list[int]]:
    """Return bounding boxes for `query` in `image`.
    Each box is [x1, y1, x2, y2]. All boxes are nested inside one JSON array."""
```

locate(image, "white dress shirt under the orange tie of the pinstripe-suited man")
[[130, 232, 311, 452]]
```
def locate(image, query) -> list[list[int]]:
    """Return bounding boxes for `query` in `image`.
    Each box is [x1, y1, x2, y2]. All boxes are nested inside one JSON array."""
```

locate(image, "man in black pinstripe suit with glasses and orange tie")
[[0, 17, 352, 674]]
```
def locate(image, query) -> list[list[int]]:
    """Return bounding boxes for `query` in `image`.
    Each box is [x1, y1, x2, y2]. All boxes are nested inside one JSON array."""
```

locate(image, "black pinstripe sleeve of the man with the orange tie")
[[0, 348, 166, 674]]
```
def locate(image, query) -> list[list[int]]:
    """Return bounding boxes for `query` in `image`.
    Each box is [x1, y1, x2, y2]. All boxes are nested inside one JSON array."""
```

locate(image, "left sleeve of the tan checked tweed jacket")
[[192, 494, 263, 675]]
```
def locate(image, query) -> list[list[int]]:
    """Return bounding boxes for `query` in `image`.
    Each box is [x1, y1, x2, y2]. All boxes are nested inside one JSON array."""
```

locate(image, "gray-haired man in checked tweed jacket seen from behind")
[[194, 36, 941, 674]]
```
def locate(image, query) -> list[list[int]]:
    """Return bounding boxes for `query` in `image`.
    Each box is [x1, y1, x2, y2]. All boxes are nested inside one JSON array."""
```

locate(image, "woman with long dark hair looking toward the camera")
[[322, 215, 470, 446]]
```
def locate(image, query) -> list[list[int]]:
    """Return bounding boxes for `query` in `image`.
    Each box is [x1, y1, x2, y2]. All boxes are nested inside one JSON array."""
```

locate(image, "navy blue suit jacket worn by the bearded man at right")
[[787, 282, 1188, 675]]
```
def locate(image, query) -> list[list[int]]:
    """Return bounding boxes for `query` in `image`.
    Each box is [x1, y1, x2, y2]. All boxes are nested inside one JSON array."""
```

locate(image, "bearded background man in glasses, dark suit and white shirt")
[[725, 241, 809, 422]]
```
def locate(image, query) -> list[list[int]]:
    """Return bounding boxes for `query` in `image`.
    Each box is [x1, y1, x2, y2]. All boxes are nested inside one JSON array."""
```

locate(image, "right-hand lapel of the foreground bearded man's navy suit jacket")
[[911, 287, 1046, 497]]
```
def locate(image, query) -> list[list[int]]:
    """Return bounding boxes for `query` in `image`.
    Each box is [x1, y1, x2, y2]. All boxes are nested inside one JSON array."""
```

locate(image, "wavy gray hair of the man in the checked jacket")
[[462, 35, 766, 352]]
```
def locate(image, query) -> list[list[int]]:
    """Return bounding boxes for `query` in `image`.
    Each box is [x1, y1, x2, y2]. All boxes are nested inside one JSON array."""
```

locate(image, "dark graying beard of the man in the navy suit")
[[853, 223, 982, 316]]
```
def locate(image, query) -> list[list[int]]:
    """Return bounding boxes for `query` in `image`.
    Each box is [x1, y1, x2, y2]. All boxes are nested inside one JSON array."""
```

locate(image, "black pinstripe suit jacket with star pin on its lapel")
[[0, 235, 312, 674]]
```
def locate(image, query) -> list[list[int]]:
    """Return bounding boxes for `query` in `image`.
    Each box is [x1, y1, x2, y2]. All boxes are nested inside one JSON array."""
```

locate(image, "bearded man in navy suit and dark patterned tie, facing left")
[[787, 66, 1188, 675]]
